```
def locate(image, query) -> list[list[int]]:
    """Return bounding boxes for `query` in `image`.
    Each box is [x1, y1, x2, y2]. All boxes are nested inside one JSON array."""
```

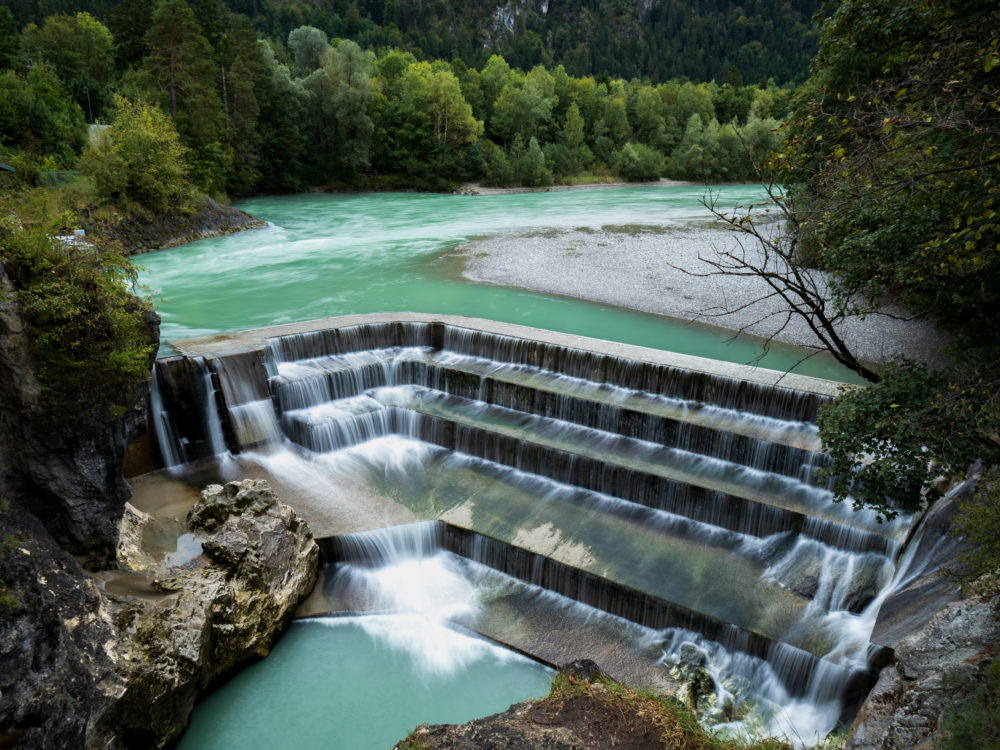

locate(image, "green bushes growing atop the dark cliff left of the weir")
[[0, 209, 154, 424]]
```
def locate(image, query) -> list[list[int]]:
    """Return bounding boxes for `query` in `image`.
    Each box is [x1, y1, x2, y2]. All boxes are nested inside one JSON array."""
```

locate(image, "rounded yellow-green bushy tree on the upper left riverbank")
[[81, 97, 193, 213]]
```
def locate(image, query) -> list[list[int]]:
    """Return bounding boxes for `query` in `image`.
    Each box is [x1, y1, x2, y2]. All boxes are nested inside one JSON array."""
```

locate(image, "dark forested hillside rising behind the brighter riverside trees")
[[7, 0, 821, 84]]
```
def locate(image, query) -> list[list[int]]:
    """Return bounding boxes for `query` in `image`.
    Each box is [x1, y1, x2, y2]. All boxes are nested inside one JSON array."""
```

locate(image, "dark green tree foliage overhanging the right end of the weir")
[[776, 0, 1000, 513]]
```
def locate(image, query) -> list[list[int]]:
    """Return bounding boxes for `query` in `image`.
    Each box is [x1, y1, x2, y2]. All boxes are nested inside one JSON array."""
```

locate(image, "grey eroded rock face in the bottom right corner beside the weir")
[[847, 598, 1000, 750]]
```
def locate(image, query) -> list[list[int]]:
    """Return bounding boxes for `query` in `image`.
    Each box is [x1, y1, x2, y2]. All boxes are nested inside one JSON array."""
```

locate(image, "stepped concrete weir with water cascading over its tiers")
[[143, 314, 928, 741]]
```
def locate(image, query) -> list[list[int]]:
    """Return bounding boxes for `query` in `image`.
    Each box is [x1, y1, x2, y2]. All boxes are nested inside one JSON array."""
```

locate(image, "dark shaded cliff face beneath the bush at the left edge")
[[0, 269, 159, 560]]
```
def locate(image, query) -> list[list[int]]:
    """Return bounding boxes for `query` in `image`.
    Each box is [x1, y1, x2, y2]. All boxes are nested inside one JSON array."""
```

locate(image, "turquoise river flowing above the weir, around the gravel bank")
[[139, 185, 868, 380]]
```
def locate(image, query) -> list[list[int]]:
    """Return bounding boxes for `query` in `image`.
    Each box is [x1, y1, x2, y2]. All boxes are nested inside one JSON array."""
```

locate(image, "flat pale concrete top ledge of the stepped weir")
[[170, 312, 850, 398]]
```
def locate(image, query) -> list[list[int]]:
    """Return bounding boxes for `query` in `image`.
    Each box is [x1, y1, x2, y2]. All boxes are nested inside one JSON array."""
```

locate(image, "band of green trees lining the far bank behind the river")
[[0, 0, 787, 194]]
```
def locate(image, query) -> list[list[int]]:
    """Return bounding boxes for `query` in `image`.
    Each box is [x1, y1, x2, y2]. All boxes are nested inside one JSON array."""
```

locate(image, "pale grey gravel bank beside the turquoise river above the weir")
[[456, 222, 945, 362]]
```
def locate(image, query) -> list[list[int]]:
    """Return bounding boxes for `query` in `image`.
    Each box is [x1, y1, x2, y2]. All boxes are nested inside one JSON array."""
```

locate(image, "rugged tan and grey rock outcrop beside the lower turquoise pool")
[[0, 480, 319, 748]]
